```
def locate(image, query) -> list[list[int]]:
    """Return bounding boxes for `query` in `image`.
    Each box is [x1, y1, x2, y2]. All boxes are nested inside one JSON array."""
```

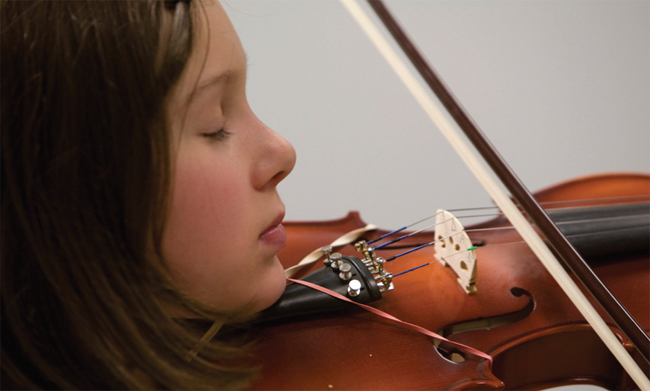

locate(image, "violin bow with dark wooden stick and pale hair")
[[341, 0, 650, 390]]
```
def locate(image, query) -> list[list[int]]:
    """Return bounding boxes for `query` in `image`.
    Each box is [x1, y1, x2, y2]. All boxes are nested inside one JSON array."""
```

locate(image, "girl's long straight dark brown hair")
[[0, 0, 251, 389]]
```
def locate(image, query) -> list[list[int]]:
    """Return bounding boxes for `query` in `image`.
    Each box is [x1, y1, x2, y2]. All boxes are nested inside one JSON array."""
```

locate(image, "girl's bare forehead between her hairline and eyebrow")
[[172, 0, 246, 107]]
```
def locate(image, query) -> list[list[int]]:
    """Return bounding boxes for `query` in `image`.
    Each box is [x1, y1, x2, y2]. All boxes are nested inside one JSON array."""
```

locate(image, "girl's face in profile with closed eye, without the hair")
[[163, 1, 296, 312]]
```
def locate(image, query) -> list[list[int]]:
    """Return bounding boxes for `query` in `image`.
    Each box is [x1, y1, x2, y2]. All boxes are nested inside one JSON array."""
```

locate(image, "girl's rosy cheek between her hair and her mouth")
[[163, 159, 246, 290]]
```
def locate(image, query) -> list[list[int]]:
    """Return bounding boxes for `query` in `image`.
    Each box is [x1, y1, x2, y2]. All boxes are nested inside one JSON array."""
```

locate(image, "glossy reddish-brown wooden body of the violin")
[[252, 174, 650, 390]]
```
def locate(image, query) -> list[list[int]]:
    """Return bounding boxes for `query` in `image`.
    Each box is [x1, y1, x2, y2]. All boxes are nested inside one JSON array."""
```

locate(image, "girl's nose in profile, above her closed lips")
[[253, 124, 296, 190]]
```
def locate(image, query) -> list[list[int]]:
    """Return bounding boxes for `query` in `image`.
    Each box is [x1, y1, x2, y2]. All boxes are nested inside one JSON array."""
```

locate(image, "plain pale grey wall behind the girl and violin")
[[223, 0, 650, 228]]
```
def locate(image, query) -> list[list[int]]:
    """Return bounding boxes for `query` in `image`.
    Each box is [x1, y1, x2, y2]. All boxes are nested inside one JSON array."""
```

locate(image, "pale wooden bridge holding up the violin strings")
[[434, 209, 476, 295]]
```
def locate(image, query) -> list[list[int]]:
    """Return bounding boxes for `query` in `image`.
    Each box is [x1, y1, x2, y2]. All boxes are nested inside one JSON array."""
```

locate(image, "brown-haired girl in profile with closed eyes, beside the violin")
[[0, 0, 295, 389]]
